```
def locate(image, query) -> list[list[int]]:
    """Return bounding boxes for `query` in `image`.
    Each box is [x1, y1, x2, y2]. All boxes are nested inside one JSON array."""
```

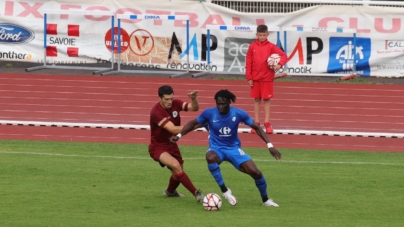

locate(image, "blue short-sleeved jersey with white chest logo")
[[196, 106, 254, 149]]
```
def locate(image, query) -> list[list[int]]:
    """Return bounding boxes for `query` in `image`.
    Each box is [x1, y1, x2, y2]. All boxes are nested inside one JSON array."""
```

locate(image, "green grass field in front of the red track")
[[0, 140, 404, 227]]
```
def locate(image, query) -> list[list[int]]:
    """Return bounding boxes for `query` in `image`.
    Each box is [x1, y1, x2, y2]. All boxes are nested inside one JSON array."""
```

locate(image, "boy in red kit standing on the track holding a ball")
[[246, 24, 287, 134]]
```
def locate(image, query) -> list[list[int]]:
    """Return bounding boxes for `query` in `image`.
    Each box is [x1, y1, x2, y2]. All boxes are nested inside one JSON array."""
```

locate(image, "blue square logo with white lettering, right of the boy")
[[327, 37, 371, 76]]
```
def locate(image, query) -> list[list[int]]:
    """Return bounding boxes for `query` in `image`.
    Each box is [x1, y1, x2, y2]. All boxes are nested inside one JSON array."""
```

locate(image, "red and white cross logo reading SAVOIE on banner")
[[46, 24, 80, 57]]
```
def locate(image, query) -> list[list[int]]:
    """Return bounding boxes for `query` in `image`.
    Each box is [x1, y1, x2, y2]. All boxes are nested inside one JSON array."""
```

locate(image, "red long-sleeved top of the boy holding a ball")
[[246, 39, 287, 81]]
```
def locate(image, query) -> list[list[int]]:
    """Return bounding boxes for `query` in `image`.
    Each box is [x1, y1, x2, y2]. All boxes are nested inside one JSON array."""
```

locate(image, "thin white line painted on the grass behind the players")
[[0, 151, 404, 166]]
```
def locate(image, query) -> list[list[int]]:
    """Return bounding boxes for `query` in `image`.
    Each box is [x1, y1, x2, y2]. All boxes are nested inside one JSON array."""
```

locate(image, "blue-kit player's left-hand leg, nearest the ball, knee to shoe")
[[206, 150, 237, 206]]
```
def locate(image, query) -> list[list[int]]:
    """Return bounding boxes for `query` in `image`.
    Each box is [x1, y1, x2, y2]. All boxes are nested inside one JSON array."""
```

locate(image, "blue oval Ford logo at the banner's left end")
[[0, 23, 35, 44]]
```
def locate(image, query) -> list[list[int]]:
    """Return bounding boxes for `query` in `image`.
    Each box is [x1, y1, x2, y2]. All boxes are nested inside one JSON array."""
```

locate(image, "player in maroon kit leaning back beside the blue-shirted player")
[[149, 85, 204, 202]]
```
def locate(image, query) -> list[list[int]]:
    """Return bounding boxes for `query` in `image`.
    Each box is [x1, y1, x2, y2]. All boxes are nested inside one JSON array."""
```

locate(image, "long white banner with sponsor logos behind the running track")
[[0, 0, 404, 77]]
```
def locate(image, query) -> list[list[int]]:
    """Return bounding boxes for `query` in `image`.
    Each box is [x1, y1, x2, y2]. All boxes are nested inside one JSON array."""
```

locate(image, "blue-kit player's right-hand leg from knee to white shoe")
[[240, 160, 279, 207]]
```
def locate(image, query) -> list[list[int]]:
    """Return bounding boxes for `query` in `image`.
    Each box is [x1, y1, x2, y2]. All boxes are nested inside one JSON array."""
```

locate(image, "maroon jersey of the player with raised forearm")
[[149, 99, 188, 150]]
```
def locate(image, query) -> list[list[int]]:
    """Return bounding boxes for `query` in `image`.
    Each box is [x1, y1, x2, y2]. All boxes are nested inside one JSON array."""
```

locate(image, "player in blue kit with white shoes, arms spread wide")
[[170, 90, 282, 207]]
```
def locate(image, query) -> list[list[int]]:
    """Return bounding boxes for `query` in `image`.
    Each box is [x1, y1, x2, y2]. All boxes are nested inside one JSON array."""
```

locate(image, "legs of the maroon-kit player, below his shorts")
[[159, 152, 203, 202]]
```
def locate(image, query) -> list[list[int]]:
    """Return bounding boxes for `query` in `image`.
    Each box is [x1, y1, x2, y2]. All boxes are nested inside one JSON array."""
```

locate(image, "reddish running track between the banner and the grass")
[[0, 73, 404, 152]]
